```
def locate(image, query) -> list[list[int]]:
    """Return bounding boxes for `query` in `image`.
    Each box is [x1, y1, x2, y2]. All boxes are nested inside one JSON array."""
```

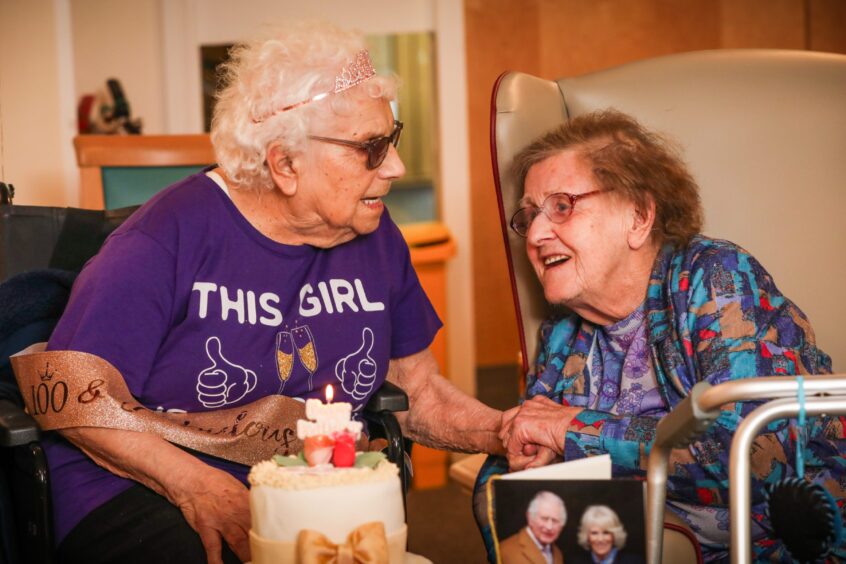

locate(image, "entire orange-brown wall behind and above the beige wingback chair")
[[464, 0, 846, 366]]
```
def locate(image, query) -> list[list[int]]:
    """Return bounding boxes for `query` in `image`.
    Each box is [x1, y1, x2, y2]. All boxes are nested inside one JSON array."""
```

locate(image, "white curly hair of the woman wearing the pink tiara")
[[211, 22, 397, 190]]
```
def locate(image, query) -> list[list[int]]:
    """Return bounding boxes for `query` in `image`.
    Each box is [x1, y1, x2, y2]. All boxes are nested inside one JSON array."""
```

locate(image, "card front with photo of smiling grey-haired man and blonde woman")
[[489, 479, 646, 564]]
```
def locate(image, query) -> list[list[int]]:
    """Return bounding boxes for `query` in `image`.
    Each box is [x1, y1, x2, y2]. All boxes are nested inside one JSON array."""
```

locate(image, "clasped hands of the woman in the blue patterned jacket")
[[499, 396, 582, 471]]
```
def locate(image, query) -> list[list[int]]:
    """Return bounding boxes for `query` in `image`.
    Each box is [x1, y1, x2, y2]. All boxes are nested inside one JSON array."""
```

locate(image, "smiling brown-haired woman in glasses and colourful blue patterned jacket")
[[477, 111, 846, 559]]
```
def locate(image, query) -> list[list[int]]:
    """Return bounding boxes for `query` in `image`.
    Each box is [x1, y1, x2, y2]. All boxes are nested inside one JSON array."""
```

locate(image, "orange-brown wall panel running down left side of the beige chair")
[[464, 0, 539, 366]]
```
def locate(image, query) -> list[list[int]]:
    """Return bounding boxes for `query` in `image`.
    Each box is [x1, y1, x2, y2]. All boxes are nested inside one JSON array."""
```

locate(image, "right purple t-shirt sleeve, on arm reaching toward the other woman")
[[389, 222, 443, 358]]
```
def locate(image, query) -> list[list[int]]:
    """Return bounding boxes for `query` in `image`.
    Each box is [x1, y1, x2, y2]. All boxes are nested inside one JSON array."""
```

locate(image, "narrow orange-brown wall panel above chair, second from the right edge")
[[720, 0, 806, 49]]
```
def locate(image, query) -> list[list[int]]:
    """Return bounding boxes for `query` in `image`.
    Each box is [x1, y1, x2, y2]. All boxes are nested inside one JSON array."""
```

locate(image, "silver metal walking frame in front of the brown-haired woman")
[[646, 374, 846, 564]]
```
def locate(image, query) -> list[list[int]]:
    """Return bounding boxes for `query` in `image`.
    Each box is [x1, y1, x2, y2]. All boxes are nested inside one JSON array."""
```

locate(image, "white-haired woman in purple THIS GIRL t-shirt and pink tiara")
[[41, 24, 502, 562]]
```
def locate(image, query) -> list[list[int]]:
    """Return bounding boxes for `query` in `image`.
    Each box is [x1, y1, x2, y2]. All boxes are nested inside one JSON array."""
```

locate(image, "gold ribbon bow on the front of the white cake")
[[297, 522, 388, 564]]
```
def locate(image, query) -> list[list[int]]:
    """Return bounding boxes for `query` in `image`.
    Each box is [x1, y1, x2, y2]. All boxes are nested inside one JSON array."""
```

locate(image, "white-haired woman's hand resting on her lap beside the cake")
[[169, 468, 250, 564]]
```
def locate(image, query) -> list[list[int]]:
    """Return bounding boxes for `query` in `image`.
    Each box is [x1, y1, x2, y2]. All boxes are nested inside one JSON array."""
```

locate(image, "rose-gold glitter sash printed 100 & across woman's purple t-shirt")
[[11, 343, 305, 465]]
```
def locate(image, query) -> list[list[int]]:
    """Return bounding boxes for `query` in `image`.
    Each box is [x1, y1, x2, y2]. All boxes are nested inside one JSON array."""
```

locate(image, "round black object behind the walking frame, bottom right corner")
[[767, 478, 843, 562]]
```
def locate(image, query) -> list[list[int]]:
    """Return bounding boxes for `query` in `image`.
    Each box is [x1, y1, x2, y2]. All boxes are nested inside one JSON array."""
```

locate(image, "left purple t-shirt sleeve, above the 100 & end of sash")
[[48, 230, 175, 397]]
